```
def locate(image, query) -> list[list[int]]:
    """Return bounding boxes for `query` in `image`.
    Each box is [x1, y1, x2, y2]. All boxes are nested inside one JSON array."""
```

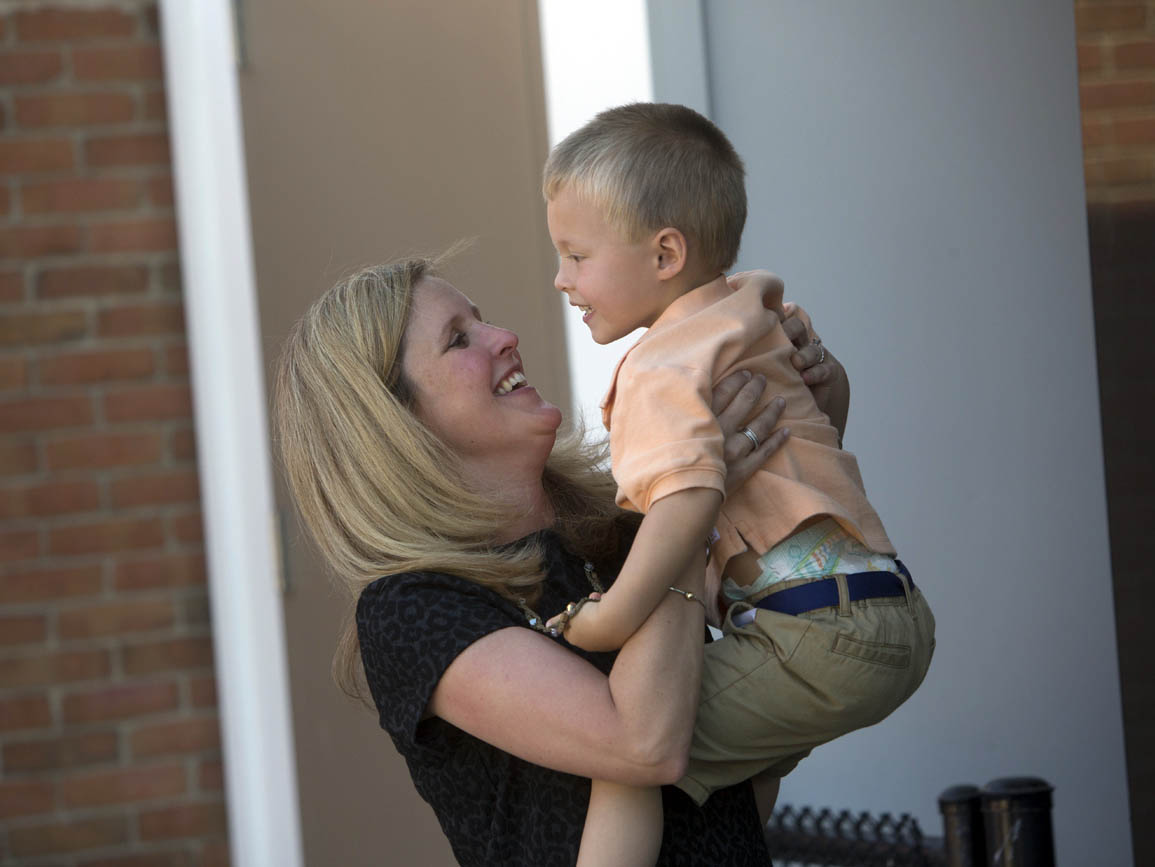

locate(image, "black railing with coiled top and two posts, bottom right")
[[766, 777, 1055, 867]]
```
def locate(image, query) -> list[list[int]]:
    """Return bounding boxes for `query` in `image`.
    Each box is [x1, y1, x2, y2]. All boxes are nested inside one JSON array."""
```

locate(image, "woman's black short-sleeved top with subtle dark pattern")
[[357, 532, 769, 867]]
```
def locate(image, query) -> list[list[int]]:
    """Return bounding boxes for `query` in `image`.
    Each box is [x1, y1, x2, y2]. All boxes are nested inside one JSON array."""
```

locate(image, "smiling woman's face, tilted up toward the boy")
[[401, 277, 561, 463]]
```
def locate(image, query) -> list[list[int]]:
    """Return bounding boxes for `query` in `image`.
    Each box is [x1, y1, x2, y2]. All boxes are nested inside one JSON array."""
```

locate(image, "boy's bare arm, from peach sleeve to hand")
[[552, 487, 722, 650]]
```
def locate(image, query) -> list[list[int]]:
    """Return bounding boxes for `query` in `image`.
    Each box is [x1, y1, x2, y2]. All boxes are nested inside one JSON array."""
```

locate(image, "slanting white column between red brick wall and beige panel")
[[161, 0, 301, 867]]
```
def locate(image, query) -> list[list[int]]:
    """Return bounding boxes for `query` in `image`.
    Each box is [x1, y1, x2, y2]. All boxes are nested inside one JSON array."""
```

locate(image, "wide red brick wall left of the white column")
[[0, 0, 228, 867]]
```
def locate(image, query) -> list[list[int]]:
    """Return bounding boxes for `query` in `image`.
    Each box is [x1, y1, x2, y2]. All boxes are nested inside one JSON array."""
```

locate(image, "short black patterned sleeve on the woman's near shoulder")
[[357, 573, 520, 755]]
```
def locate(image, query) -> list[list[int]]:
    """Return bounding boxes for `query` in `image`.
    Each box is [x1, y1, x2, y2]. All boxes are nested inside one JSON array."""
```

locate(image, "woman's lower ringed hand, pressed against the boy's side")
[[710, 371, 790, 496]]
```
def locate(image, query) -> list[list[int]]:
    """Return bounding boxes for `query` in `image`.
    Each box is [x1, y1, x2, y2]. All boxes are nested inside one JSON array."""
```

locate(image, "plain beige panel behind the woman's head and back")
[[241, 0, 569, 865]]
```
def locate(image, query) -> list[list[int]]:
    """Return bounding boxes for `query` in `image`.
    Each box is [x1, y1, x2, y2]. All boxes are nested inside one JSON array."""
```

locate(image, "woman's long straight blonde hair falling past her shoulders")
[[274, 259, 636, 696]]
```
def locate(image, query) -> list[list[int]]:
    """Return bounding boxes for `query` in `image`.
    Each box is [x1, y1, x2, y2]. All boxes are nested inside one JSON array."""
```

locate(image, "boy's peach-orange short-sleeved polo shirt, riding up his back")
[[602, 277, 895, 565]]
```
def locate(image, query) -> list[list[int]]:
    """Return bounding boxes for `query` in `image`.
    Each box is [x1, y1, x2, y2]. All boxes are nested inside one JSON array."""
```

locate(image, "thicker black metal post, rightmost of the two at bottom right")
[[982, 777, 1055, 867]]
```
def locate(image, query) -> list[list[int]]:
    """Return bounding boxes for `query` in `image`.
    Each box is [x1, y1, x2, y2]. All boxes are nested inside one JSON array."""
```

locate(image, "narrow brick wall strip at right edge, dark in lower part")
[[1075, 0, 1155, 865]]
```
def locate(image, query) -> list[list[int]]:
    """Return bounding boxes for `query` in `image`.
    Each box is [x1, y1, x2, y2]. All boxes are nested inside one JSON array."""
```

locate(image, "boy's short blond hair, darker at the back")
[[542, 103, 746, 271]]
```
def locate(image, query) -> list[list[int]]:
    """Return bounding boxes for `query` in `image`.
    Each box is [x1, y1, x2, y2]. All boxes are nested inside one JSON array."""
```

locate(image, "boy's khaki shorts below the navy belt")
[[677, 576, 934, 805]]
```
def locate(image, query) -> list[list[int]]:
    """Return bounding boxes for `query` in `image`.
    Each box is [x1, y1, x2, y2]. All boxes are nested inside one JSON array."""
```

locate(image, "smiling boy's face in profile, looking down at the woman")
[[546, 188, 672, 344]]
